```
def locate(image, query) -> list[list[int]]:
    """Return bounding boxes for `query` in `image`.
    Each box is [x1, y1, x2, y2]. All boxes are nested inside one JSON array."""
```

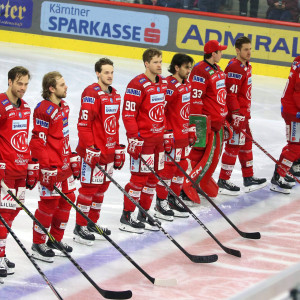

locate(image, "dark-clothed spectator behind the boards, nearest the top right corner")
[[267, 0, 299, 22]]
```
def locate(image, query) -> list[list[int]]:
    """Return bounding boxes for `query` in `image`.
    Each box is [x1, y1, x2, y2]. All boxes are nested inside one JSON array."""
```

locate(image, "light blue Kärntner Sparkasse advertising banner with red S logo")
[[40, 1, 169, 46]]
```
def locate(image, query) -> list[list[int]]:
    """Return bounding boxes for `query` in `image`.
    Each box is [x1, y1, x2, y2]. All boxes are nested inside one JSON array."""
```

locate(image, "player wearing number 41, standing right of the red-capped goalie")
[[218, 36, 267, 195]]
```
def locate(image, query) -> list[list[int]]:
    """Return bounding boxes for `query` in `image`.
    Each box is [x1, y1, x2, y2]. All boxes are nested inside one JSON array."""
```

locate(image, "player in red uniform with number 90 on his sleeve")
[[120, 48, 173, 233]]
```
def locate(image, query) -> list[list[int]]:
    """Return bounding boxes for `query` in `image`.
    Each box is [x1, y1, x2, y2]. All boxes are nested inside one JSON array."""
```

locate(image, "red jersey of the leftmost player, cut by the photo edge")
[[0, 93, 30, 179]]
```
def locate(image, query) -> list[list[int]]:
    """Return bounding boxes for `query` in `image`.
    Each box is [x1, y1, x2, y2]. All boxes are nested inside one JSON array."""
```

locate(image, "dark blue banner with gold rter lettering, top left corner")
[[0, 0, 33, 28]]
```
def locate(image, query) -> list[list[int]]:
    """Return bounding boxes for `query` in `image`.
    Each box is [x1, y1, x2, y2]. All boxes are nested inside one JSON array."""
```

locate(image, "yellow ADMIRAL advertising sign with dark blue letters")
[[176, 18, 300, 63]]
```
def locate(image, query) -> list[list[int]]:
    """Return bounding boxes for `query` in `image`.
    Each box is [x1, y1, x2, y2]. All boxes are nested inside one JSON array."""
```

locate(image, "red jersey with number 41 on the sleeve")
[[225, 58, 252, 119]]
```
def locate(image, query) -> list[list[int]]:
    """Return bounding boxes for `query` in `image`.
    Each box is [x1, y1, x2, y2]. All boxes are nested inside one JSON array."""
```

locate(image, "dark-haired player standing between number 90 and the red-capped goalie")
[[155, 53, 197, 221]]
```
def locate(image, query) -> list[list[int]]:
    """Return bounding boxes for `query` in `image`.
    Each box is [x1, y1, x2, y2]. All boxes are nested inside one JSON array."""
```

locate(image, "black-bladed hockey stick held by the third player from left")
[[97, 164, 218, 263]]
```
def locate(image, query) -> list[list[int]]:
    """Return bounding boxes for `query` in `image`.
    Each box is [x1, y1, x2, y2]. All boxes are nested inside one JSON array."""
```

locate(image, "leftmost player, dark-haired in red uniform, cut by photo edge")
[[0, 66, 39, 282]]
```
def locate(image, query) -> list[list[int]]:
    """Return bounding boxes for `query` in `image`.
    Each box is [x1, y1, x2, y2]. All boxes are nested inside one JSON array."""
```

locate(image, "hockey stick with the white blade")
[[54, 186, 177, 286]]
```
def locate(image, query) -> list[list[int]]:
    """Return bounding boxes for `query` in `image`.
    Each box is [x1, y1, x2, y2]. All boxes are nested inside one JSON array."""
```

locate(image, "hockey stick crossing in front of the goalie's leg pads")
[[167, 154, 260, 239]]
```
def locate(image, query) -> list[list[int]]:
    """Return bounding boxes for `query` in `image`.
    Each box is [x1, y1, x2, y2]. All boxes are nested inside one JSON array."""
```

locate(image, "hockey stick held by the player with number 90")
[[140, 156, 241, 257]]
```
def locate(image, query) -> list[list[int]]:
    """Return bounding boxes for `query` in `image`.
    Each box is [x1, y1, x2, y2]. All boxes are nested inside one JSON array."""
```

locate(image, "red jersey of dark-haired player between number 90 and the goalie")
[[165, 76, 191, 148]]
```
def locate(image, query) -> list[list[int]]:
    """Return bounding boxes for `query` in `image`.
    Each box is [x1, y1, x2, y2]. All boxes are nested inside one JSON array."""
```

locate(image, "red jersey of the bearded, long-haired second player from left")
[[30, 100, 72, 181]]
